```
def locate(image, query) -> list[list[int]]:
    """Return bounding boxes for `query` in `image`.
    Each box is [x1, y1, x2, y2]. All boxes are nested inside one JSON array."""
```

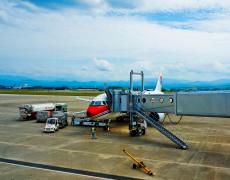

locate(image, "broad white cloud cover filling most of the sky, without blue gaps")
[[0, 0, 230, 80]]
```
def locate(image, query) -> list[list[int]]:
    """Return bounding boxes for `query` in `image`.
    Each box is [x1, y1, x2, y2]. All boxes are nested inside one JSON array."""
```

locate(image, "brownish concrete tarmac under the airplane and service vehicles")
[[0, 95, 230, 180]]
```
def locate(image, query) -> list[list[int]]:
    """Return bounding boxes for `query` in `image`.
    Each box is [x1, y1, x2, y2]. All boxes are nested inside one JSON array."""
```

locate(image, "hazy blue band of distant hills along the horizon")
[[0, 75, 230, 90]]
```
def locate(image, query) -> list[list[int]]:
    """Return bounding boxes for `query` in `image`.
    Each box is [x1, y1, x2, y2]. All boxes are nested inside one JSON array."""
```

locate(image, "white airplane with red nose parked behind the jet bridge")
[[76, 73, 165, 123]]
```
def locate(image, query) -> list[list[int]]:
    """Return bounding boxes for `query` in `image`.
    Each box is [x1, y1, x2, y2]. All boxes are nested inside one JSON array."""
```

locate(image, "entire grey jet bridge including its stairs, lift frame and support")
[[106, 71, 230, 149]]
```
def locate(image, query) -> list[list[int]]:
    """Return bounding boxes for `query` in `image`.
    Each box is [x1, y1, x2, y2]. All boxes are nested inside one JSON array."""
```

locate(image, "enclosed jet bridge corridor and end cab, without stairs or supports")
[[109, 89, 230, 117]]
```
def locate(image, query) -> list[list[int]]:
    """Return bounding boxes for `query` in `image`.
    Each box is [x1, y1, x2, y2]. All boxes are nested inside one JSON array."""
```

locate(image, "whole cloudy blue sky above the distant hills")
[[0, 0, 230, 81]]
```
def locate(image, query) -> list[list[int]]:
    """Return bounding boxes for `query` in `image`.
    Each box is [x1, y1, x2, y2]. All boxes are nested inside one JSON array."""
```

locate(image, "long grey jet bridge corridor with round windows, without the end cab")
[[133, 91, 230, 117]]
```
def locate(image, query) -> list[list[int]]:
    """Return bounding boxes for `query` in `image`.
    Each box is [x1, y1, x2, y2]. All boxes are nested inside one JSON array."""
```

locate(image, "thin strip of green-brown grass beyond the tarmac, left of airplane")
[[0, 89, 103, 96]]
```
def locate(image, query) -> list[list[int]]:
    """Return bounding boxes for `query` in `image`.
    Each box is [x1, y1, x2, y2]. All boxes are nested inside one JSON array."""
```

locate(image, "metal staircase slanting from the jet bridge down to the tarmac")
[[135, 109, 188, 149]]
